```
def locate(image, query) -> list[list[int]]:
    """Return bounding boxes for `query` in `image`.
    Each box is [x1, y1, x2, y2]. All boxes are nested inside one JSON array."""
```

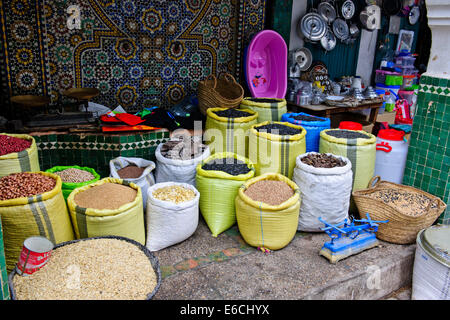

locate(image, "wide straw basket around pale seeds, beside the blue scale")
[[352, 176, 447, 244]]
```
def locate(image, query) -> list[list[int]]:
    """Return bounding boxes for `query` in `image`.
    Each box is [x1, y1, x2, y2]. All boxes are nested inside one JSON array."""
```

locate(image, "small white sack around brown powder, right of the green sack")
[[109, 157, 156, 210]]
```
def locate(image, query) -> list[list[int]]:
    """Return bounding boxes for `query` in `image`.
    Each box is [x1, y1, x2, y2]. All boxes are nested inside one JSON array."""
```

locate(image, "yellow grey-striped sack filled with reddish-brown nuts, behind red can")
[[0, 172, 74, 272]]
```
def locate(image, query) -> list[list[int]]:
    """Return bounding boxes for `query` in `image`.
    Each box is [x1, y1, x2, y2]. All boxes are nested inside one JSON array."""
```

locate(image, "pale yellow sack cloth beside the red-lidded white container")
[[319, 129, 376, 191]]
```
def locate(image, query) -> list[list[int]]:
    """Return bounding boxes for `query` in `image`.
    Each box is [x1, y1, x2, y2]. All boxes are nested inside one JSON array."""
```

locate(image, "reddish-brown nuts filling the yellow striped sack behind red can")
[[0, 172, 56, 200]]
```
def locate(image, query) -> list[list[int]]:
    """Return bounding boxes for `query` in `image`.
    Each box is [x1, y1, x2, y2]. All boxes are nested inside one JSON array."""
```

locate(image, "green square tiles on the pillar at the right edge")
[[403, 76, 450, 224]]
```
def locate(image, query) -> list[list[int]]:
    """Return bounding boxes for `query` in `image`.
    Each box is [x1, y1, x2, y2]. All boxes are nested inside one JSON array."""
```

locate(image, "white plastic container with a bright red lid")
[[374, 129, 408, 184]]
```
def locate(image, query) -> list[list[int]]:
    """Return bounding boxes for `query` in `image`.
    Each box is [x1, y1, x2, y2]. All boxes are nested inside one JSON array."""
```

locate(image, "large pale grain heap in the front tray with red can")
[[13, 239, 157, 300]]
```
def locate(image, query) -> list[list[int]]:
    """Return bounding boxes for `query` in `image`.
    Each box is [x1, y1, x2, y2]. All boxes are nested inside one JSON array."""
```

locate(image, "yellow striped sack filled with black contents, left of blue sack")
[[249, 121, 307, 179]]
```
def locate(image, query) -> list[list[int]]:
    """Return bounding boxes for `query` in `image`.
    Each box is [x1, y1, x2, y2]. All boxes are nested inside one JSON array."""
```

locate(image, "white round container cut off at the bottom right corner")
[[411, 225, 450, 300]]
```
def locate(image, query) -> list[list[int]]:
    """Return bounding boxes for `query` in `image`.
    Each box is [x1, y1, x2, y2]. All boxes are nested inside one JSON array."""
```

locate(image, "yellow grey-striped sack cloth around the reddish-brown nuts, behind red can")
[[0, 172, 74, 272]]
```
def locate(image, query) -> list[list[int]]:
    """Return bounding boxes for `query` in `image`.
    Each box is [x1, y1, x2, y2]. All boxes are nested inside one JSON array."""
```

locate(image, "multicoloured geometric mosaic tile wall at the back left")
[[0, 0, 266, 112]]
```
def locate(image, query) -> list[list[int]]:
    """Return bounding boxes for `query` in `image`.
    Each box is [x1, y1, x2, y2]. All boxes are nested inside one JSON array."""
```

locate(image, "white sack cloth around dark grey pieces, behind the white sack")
[[155, 143, 211, 187]]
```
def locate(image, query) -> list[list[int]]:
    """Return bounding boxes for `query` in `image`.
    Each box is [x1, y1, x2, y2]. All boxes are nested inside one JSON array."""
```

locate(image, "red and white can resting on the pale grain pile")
[[16, 236, 54, 275]]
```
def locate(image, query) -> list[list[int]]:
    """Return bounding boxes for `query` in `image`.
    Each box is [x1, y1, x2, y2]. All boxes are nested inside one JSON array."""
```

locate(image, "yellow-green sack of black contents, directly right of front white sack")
[[197, 152, 255, 237]]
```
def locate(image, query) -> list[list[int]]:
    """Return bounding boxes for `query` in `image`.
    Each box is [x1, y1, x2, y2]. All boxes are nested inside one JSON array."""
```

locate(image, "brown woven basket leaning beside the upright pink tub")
[[198, 73, 244, 115]]
